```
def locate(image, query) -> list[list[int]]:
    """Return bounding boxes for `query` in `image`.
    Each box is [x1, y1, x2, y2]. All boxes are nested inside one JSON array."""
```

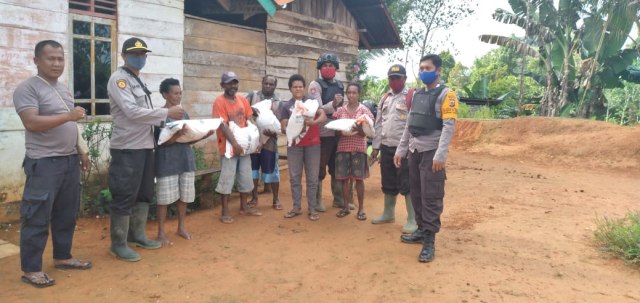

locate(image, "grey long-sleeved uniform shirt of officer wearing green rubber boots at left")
[[107, 67, 168, 149]]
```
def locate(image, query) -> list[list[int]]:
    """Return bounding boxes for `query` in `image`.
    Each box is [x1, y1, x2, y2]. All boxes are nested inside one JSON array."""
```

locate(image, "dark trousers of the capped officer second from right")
[[380, 145, 409, 196]]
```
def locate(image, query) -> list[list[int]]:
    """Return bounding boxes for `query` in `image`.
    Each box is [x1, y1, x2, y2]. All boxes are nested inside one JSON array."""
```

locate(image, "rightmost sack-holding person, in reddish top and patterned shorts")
[[333, 83, 374, 221]]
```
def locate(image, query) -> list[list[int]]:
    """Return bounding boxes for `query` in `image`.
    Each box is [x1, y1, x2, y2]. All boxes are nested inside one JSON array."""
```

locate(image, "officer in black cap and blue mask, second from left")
[[107, 38, 184, 262]]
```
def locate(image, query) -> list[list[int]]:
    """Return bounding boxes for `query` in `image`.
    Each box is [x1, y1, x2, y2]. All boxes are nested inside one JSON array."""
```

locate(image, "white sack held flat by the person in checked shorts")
[[158, 118, 222, 145]]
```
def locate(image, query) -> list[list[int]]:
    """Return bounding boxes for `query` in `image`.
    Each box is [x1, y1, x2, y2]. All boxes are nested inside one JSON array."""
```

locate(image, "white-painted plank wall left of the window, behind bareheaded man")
[[0, 0, 70, 205]]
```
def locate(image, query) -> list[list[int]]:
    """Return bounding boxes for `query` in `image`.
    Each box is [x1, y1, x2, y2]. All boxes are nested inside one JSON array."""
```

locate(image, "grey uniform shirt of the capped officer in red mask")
[[372, 88, 409, 149]]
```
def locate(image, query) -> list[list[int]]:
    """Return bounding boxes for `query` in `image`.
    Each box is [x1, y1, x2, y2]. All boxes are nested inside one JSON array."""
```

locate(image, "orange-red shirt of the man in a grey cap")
[[211, 94, 253, 155]]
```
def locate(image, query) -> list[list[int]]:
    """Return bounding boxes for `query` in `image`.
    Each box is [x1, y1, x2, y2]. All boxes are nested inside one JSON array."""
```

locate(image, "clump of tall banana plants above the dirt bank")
[[480, 0, 640, 118]]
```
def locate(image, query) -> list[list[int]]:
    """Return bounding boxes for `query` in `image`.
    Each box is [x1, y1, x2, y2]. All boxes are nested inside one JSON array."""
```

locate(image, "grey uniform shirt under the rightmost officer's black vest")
[[396, 87, 456, 162]]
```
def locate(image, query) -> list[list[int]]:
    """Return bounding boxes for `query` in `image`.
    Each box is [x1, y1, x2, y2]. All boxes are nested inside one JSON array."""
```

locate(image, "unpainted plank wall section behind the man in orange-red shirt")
[[183, 16, 266, 117]]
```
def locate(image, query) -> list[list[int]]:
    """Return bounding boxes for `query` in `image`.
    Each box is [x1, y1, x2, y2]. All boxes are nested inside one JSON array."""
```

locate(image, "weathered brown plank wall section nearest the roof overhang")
[[266, 9, 358, 98]]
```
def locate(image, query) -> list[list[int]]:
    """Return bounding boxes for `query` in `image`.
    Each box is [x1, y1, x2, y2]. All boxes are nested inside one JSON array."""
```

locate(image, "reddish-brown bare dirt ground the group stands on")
[[0, 118, 640, 302]]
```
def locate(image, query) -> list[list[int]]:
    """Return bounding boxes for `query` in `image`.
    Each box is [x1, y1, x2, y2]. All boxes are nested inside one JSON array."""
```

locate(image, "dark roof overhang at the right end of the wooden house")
[[342, 0, 403, 49]]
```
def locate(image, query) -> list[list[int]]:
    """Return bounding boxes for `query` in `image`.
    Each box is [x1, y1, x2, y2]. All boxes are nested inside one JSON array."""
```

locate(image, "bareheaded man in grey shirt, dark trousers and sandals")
[[13, 40, 91, 287]]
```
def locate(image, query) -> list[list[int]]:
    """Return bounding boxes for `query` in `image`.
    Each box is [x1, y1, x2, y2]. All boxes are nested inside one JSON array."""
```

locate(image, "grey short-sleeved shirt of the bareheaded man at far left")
[[13, 77, 78, 159]]
